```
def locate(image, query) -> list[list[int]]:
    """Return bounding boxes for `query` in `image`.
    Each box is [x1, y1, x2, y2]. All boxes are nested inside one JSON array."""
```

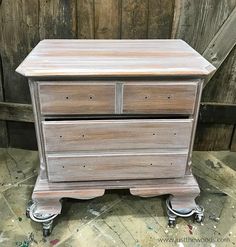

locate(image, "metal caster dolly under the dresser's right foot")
[[166, 198, 204, 228]]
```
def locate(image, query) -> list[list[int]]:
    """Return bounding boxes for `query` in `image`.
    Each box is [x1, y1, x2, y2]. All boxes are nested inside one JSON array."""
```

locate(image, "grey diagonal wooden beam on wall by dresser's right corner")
[[202, 7, 236, 87]]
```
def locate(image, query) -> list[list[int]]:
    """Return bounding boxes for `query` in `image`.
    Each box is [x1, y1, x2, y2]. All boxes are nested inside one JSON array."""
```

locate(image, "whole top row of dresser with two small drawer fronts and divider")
[[38, 80, 198, 115]]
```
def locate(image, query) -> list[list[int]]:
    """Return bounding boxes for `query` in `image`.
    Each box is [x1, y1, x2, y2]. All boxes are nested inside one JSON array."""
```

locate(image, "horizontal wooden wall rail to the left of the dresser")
[[0, 102, 34, 122]]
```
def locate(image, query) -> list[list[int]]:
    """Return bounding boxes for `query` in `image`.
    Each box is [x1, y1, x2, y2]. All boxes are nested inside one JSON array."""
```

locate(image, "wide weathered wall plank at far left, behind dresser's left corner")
[[0, 0, 39, 147]]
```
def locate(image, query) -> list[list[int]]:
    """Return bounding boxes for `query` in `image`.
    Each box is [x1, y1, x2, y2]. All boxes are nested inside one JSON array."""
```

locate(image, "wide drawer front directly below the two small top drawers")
[[42, 119, 192, 152]]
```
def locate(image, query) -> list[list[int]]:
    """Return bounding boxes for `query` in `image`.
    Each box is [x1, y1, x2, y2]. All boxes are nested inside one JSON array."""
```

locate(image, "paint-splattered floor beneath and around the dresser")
[[0, 149, 236, 247]]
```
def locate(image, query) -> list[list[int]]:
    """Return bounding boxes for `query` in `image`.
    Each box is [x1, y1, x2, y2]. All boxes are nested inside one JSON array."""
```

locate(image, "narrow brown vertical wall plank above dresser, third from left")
[[77, 0, 95, 39]]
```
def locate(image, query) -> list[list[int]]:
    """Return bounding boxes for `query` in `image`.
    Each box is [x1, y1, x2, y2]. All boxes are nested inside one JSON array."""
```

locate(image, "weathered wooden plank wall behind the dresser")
[[0, 0, 236, 150]]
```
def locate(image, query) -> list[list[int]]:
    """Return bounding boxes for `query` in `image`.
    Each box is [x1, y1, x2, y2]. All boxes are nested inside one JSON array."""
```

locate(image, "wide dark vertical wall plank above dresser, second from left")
[[39, 0, 77, 39]]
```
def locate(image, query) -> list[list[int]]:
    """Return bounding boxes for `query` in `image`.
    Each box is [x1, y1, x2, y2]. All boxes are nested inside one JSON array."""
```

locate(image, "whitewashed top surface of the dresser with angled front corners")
[[16, 39, 215, 77]]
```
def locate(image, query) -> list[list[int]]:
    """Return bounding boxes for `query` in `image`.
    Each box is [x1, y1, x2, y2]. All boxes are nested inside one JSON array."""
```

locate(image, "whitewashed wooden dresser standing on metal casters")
[[16, 40, 215, 236]]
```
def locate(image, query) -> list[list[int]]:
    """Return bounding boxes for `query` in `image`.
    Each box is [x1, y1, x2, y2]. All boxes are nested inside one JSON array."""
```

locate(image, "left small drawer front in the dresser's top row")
[[39, 82, 115, 115]]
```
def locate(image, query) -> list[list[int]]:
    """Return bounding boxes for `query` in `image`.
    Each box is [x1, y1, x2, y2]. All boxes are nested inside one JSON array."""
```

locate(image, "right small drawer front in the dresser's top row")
[[123, 83, 197, 114]]
